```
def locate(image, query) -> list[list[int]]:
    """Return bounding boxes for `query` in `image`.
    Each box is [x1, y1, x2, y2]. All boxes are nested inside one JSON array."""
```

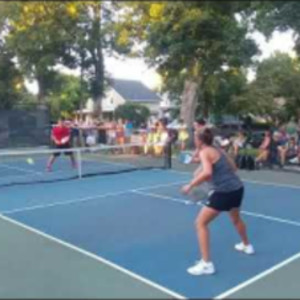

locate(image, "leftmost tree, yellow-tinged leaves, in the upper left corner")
[[1, 1, 78, 103]]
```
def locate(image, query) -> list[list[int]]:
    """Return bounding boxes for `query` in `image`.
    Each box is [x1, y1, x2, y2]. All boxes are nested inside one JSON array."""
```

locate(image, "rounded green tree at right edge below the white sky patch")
[[235, 53, 300, 120]]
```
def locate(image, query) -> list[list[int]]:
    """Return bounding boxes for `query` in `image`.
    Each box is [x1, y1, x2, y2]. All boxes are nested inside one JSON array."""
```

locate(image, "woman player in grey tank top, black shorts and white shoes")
[[182, 128, 254, 275]]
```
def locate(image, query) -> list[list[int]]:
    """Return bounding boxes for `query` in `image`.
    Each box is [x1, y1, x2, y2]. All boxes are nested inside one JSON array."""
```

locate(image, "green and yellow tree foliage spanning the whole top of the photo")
[[0, 1, 300, 123]]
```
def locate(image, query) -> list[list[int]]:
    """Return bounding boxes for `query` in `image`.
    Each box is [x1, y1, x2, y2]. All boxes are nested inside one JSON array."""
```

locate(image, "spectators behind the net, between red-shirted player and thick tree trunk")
[[61, 119, 182, 155]]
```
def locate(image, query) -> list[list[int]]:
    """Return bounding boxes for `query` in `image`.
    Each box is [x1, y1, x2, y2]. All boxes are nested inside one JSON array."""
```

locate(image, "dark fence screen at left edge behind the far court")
[[0, 108, 51, 148]]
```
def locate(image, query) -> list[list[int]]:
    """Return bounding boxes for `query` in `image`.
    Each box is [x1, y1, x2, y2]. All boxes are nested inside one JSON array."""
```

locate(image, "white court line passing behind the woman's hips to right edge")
[[132, 190, 300, 227]]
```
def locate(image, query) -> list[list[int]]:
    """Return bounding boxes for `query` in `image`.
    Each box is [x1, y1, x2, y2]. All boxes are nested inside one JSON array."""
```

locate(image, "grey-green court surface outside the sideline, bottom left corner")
[[0, 218, 174, 299]]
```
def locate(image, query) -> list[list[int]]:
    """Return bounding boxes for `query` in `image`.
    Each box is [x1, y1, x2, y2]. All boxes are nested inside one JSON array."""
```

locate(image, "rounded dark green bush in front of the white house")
[[115, 103, 150, 126]]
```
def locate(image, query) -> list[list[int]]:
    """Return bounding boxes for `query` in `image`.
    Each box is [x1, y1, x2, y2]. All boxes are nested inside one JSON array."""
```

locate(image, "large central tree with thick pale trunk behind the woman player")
[[115, 1, 257, 124]]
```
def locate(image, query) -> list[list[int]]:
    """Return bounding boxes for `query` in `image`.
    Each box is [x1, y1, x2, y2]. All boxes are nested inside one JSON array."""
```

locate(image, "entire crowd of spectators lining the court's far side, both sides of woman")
[[54, 119, 300, 168]]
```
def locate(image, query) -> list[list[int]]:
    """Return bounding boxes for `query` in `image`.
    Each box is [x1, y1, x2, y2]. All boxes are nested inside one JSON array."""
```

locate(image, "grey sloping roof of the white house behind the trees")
[[111, 79, 162, 103]]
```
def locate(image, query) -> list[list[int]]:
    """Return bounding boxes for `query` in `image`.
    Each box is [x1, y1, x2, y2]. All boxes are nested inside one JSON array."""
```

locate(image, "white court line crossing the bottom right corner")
[[214, 252, 300, 299]]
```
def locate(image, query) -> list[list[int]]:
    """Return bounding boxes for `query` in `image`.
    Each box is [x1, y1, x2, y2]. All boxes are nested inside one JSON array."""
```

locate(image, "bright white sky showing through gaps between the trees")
[[26, 31, 295, 94]]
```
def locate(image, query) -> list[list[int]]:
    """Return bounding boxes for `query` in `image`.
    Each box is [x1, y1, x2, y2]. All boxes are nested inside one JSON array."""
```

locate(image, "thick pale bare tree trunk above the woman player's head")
[[180, 80, 199, 128]]
